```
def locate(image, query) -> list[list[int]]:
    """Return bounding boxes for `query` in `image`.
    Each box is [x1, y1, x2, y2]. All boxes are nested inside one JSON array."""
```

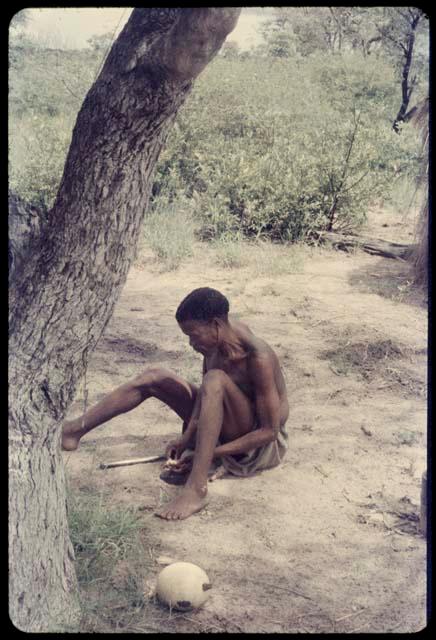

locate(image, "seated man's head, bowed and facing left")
[[176, 287, 229, 355]]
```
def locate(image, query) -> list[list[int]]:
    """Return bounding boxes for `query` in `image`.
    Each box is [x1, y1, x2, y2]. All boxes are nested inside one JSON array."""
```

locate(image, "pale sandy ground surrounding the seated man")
[[64, 206, 427, 633]]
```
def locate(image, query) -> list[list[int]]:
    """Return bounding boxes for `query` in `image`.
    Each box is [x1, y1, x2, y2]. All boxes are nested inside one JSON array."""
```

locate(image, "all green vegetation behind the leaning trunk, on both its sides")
[[9, 7, 428, 251]]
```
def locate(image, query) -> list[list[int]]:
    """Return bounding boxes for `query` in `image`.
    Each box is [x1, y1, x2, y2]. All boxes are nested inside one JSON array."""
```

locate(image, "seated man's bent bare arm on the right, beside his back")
[[214, 353, 280, 458]]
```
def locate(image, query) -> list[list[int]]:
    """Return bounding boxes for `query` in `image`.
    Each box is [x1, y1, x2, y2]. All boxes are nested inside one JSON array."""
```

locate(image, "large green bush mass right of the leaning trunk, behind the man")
[[155, 54, 419, 241]]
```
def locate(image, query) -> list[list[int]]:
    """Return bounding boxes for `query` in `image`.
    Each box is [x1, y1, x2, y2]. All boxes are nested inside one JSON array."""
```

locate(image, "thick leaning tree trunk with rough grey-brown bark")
[[9, 7, 240, 632]]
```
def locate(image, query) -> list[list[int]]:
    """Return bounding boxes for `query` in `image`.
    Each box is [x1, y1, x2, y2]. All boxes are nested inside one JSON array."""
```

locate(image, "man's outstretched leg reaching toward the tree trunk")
[[62, 368, 197, 451]]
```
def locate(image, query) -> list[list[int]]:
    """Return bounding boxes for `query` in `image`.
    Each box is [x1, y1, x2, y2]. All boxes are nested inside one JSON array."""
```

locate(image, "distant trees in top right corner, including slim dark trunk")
[[261, 7, 429, 130]]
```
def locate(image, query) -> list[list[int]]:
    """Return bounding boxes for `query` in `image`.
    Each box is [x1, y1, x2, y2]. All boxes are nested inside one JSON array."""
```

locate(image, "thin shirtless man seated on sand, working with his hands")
[[62, 287, 289, 520]]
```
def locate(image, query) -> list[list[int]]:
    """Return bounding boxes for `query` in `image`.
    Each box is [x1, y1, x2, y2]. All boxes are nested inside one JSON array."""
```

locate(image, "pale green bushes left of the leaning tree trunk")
[[9, 45, 101, 209]]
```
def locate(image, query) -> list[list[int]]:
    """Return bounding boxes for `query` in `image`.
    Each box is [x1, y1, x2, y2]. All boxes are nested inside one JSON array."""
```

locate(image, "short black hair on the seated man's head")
[[176, 287, 230, 323]]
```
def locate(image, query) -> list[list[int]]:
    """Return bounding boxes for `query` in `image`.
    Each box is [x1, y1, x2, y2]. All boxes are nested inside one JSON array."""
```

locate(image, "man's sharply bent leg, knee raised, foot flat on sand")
[[156, 369, 254, 520]]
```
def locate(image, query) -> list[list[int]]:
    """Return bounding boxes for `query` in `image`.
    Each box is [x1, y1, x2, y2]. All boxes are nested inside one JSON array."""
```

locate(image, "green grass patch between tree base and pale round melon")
[[68, 490, 149, 632]]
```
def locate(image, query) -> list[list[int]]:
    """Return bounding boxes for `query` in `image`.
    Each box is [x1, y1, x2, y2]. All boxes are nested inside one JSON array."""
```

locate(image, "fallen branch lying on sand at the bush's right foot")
[[311, 231, 416, 261]]
